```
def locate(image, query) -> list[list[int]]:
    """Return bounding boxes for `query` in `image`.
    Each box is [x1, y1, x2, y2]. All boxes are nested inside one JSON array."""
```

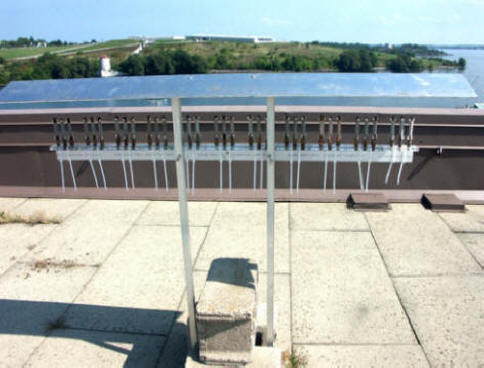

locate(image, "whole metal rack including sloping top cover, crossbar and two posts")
[[40, 73, 476, 348]]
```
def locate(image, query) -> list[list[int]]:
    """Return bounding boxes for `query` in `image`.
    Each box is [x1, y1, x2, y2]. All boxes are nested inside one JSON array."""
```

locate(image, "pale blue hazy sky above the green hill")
[[0, 0, 484, 43]]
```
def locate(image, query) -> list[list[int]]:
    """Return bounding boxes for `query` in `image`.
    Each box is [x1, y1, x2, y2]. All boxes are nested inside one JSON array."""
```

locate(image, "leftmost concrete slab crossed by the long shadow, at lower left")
[[0, 263, 95, 367]]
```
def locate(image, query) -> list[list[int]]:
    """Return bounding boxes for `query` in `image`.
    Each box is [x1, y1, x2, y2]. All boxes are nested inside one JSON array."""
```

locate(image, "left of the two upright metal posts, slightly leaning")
[[171, 97, 197, 349]]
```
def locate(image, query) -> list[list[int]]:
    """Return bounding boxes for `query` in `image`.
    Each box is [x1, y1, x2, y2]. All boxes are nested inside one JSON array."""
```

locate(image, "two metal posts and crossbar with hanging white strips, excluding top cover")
[[51, 105, 417, 348]]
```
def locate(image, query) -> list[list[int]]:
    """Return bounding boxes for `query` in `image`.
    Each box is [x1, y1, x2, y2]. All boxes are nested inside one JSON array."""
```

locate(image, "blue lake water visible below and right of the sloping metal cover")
[[0, 49, 484, 109]]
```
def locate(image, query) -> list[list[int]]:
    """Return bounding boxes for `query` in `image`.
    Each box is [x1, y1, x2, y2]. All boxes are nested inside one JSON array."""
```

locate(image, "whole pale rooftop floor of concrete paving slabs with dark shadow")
[[0, 198, 484, 368]]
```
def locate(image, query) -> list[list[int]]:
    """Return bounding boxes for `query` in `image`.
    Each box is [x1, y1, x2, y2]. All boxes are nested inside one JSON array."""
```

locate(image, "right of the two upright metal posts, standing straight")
[[266, 97, 275, 346]]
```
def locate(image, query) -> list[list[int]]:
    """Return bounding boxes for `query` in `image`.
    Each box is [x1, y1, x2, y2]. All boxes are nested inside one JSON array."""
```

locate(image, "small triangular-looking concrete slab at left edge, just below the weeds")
[[0, 224, 56, 275]]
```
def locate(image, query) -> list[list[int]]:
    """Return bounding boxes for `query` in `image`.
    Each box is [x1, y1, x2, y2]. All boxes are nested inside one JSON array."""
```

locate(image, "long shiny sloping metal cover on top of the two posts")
[[0, 73, 476, 103]]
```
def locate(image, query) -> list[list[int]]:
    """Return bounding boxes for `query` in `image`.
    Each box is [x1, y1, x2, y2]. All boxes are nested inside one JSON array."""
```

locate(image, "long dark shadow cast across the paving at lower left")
[[0, 299, 183, 367]]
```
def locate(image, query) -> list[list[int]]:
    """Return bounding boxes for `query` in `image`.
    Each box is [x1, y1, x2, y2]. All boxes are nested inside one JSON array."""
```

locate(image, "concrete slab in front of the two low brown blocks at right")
[[366, 204, 480, 276]]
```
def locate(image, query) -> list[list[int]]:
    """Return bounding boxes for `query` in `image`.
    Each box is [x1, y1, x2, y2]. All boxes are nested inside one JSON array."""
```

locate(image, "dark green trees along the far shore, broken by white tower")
[[0, 46, 466, 85]]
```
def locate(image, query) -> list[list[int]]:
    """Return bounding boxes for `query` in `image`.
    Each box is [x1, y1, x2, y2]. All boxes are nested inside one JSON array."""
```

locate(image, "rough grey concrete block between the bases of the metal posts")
[[196, 258, 258, 364]]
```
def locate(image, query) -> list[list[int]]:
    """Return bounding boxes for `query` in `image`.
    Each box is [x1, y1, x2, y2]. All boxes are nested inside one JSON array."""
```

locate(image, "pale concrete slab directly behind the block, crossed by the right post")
[[195, 202, 289, 272]]
